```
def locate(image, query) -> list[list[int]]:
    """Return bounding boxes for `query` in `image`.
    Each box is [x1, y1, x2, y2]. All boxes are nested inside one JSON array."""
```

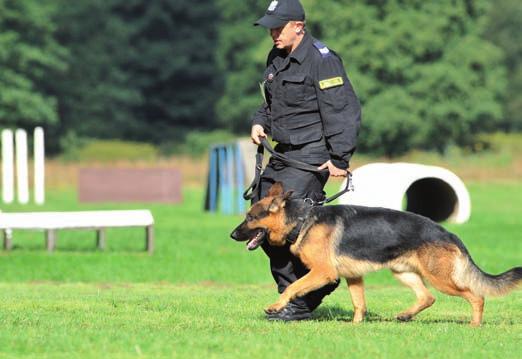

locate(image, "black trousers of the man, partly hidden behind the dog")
[[254, 160, 339, 310]]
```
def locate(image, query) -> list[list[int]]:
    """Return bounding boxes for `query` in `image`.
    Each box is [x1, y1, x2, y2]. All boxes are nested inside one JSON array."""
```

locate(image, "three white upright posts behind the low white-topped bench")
[[2, 127, 45, 204]]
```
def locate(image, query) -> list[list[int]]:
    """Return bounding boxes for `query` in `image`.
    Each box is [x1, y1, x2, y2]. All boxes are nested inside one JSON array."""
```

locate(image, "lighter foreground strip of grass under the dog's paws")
[[0, 283, 522, 358]]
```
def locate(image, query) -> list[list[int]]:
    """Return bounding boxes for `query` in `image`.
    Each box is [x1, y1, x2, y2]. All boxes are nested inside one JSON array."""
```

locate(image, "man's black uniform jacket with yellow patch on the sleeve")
[[252, 34, 361, 169]]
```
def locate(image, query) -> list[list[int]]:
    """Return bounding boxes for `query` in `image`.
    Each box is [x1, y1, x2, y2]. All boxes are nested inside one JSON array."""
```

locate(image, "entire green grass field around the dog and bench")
[[0, 181, 522, 358]]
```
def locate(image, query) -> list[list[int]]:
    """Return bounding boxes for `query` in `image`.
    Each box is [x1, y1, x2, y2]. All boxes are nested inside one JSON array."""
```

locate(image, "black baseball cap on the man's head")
[[254, 0, 305, 29]]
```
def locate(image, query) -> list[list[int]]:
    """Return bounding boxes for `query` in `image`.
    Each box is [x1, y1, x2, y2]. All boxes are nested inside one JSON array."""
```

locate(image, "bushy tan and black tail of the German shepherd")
[[453, 238, 522, 297]]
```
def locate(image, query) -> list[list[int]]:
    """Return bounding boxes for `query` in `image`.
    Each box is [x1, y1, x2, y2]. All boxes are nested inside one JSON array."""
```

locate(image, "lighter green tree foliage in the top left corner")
[[0, 0, 67, 127]]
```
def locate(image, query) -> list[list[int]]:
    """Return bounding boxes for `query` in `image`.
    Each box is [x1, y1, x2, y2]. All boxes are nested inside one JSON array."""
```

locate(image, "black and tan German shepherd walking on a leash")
[[231, 183, 522, 326]]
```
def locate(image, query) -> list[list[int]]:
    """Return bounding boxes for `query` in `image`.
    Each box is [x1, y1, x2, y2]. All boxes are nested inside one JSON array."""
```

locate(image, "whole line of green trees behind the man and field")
[[0, 0, 522, 156]]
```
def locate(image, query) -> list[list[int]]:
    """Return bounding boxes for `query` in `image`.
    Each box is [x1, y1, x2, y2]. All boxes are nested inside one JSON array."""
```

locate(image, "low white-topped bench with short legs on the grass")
[[0, 210, 154, 254]]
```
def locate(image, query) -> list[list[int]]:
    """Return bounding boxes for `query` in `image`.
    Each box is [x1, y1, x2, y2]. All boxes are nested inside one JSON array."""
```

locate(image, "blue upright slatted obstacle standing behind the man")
[[205, 142, 255, 214]]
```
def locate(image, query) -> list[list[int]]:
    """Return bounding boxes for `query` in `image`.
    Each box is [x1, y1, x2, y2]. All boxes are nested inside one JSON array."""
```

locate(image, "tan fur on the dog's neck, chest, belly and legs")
[[267, 219, 484, 326]]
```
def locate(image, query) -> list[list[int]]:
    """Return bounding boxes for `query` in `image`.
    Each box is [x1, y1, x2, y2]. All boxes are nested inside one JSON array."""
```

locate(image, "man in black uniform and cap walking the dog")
[[251, 0, 361, 321]]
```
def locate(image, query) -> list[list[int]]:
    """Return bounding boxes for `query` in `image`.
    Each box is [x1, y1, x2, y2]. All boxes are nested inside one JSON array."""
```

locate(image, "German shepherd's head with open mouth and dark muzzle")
[[230, 182, 292, 251]]
